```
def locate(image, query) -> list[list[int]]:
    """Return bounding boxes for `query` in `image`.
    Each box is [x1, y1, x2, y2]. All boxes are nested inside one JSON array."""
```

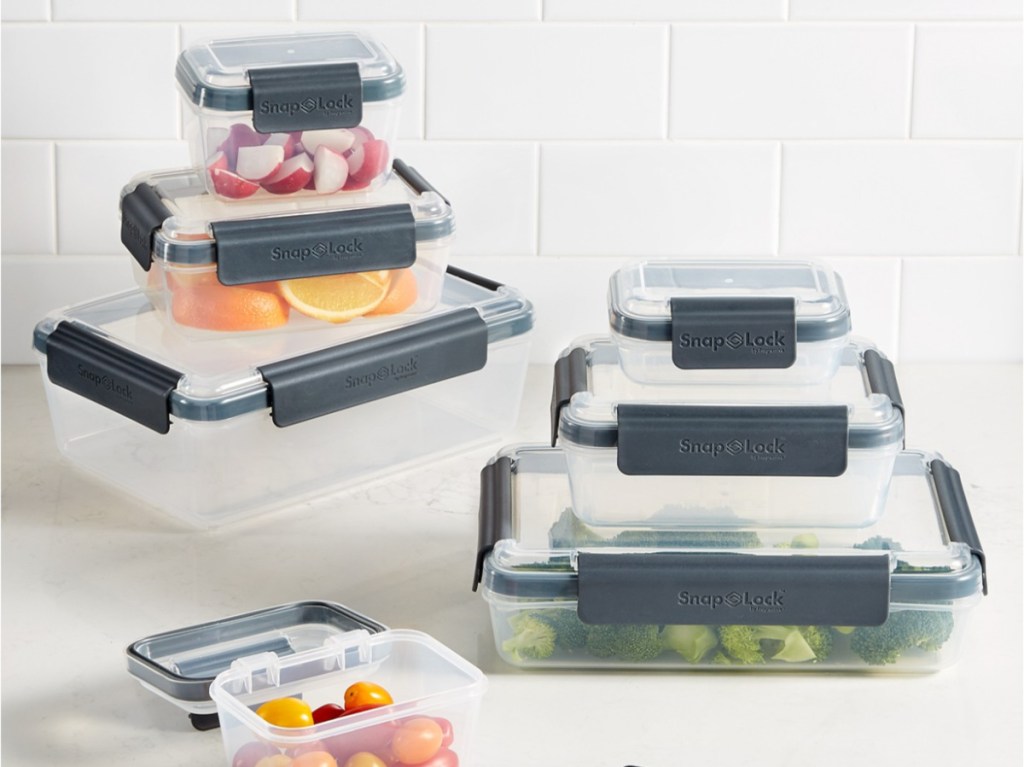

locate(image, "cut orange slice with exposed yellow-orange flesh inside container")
[[280, 272, 391, 323]]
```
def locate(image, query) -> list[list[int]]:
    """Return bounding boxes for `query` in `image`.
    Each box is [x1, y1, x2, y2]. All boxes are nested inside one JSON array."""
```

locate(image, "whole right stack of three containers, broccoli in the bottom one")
[[474, 261, 985, 671]]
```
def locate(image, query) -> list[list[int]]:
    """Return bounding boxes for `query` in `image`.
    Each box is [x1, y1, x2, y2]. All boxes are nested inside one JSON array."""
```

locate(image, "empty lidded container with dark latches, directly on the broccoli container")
[[552, 339, 903, 527]]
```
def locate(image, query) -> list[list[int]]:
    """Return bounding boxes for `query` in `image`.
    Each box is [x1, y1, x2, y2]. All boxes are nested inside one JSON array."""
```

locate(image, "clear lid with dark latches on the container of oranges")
[[121, 160, 455, 285]]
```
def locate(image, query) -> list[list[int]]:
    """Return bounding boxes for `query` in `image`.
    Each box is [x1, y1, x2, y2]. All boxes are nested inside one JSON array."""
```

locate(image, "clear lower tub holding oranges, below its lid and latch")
[[132, 237, 454, 340]]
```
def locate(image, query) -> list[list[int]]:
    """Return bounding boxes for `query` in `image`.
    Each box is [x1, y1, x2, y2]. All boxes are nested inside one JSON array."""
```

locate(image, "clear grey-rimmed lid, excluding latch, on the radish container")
[[175, 32, 406, 113]]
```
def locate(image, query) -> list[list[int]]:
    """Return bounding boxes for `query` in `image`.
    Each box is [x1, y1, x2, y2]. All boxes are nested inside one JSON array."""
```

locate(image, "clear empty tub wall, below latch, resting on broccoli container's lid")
[[562, 441, 899, 527]]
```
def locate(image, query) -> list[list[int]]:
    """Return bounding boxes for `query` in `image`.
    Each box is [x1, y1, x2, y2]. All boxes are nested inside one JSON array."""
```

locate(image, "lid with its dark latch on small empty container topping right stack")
[[608, 260, 850, 367]]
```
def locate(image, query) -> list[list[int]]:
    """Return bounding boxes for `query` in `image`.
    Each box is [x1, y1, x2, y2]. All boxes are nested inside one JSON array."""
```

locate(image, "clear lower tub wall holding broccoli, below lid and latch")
[[484, 593, 981, 673]]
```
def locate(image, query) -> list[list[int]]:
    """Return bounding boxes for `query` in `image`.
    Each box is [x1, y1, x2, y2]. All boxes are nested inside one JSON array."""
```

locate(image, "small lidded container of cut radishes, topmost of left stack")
[[175, 32, 406, 200]]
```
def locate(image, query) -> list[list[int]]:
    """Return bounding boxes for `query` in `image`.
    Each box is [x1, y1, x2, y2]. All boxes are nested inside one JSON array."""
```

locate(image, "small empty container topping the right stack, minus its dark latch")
[[608, 260, 850, 385]]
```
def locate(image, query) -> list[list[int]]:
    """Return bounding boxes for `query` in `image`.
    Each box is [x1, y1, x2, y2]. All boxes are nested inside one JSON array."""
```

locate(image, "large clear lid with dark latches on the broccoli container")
[[474, 445, 987, 626]]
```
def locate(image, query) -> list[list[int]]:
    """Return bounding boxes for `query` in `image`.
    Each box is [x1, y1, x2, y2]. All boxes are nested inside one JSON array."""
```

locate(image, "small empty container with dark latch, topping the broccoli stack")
[[608, 260, 850, 384]]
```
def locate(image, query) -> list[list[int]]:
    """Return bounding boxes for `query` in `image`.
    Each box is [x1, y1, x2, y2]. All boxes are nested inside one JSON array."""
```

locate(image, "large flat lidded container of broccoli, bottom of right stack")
[[474, 445, 986, 672]]
